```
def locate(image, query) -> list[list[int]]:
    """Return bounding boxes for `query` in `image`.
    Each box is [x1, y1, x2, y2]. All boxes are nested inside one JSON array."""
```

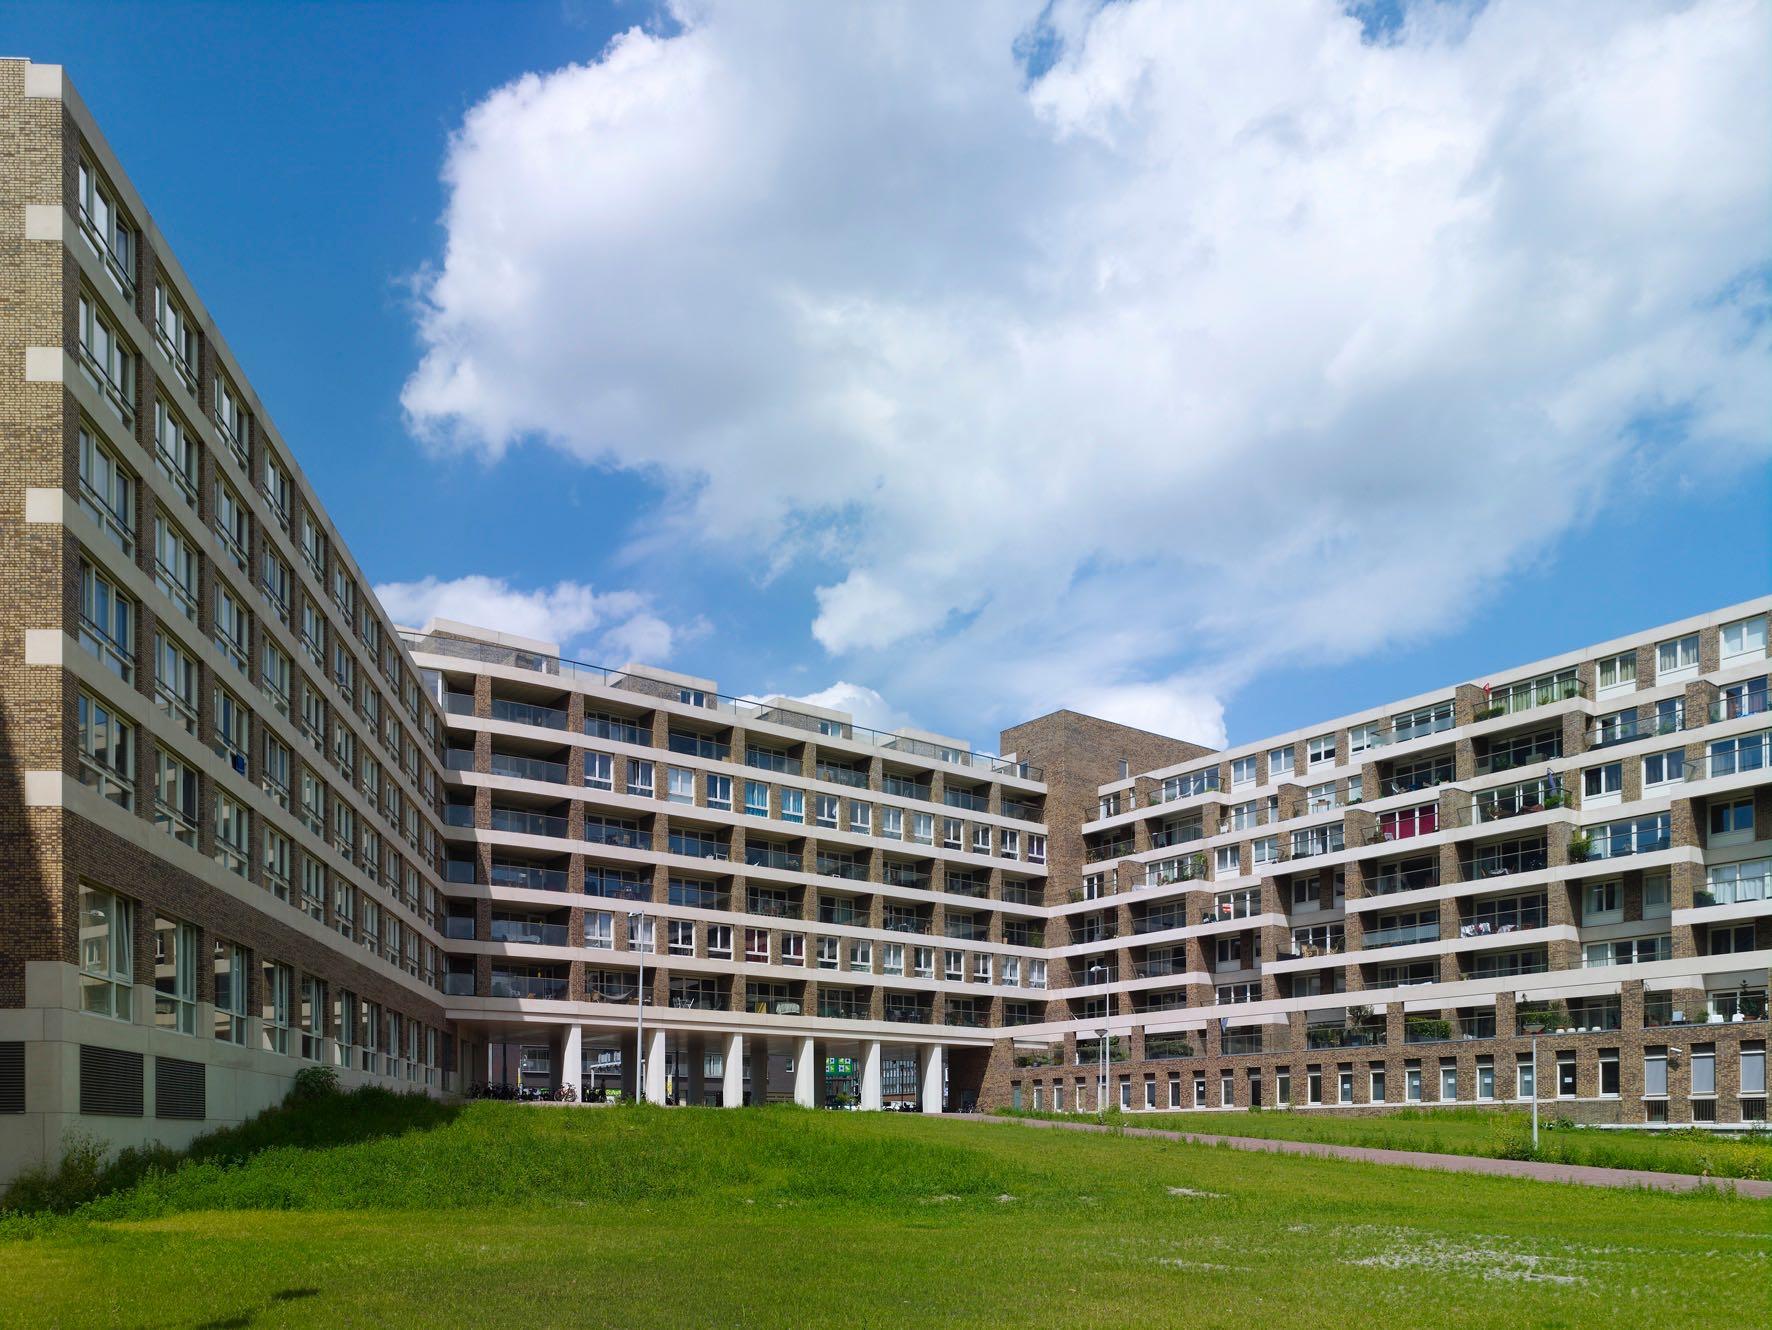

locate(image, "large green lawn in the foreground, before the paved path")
[[0, 1100, 1772, 1330]]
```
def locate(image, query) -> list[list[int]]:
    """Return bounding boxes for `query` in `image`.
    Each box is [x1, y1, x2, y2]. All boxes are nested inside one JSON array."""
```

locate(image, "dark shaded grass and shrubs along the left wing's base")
[[0, 1086, 461, 1225]]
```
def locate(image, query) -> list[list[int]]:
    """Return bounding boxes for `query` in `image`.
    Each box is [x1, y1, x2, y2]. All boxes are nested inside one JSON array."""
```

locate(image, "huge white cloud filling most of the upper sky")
[[404, 0, 1772, 735]]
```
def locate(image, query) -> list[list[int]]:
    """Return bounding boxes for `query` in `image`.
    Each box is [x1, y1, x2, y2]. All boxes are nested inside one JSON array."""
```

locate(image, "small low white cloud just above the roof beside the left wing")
[[376, 574, 683, 664]]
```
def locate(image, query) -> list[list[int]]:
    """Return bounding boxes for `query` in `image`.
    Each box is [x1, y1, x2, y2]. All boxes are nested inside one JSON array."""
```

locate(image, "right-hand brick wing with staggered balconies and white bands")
[[1013, 600, 1772, 1125]]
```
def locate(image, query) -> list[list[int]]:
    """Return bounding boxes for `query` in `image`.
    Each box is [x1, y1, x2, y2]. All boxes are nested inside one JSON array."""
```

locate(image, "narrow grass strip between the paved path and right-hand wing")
[[1012, 1109, 1772, 1178]]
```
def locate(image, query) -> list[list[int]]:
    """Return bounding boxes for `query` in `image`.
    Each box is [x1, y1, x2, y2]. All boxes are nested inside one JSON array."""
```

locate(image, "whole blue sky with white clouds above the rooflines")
[[17, 0, 1772, 747]]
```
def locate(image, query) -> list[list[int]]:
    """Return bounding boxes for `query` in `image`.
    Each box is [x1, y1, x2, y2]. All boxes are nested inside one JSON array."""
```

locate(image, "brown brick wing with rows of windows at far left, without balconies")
[[0, 60, 474, 1176]]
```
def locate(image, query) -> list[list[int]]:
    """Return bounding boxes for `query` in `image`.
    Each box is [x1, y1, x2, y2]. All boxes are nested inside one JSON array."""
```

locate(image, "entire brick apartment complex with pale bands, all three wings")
[[0, 60, 1772, 1176]]
